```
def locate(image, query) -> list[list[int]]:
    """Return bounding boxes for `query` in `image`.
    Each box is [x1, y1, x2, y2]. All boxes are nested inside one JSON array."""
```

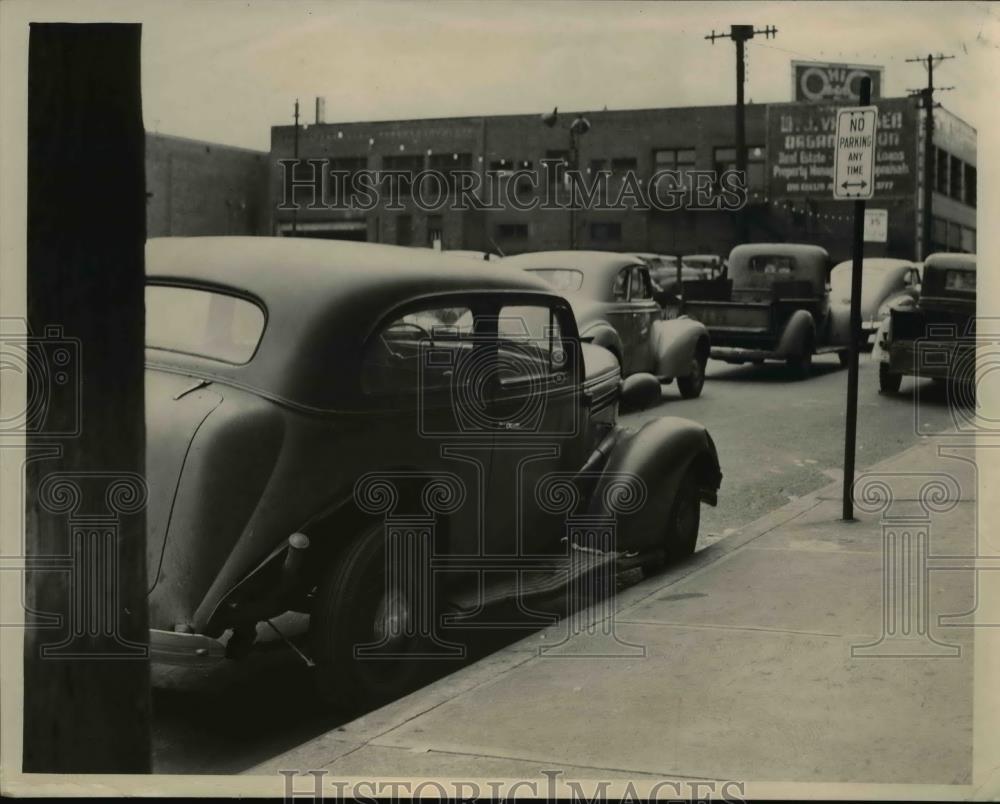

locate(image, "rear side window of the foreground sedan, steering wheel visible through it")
[[361, 303, 474, 394]]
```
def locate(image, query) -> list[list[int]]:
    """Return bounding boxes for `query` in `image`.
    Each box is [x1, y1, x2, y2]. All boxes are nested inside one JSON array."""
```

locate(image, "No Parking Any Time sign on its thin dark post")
[[833, 78, 878, 520]]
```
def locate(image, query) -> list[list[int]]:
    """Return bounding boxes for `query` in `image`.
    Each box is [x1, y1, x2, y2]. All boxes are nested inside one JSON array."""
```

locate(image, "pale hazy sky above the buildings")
[[3, 0, 1000, 150]]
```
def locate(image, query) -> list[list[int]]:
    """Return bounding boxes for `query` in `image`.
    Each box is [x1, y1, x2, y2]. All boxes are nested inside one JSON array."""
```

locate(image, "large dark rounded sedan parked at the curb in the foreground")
[[146, 237, 721, 710]]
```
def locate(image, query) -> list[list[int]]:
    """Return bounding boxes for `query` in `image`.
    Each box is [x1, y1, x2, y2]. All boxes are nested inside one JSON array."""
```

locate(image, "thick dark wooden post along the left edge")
[[23, 23, 150, 773]]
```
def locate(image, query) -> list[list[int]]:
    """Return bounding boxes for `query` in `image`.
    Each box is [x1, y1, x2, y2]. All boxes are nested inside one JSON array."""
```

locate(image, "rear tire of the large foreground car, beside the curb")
[[310, 523, 426, 713]]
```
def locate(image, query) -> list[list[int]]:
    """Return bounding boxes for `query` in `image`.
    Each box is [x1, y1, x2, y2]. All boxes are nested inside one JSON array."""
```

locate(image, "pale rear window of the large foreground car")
[[146, 285, 265, 365]]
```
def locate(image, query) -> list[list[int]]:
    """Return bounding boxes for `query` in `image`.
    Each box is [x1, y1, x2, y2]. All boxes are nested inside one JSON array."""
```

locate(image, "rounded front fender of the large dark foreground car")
[[588, 416, 722, 550]]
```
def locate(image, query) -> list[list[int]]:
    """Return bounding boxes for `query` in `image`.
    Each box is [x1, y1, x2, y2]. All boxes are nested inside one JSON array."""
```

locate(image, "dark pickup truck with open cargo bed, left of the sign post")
[[682, 243, 850, 376]]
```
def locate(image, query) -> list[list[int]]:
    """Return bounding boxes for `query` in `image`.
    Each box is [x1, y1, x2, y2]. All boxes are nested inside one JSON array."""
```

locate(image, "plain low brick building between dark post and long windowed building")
[[146, 133, 271, 237]]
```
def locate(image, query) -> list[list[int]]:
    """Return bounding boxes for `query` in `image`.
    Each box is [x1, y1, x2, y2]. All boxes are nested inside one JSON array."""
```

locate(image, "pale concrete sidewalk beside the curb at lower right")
[[248, 442, 977, 785]]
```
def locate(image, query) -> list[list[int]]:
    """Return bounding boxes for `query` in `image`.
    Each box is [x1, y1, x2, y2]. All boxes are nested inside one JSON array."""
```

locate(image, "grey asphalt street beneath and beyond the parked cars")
[[153, 355, 952, 774]]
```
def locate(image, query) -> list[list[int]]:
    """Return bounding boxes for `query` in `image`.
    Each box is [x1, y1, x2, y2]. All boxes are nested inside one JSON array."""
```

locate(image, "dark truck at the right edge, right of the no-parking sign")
[[872, 248, 976, 394]]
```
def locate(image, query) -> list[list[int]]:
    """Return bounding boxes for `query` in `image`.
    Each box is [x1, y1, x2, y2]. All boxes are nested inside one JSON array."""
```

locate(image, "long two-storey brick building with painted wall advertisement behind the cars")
[[269, 98, 976, 260]]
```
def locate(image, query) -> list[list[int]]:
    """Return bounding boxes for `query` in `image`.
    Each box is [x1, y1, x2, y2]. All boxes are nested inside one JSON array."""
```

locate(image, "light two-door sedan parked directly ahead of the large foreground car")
[[503, 251, 711, 399]]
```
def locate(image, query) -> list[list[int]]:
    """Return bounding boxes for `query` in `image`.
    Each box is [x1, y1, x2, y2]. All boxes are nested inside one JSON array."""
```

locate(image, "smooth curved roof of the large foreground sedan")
[[146, 232, 558, 410]]
